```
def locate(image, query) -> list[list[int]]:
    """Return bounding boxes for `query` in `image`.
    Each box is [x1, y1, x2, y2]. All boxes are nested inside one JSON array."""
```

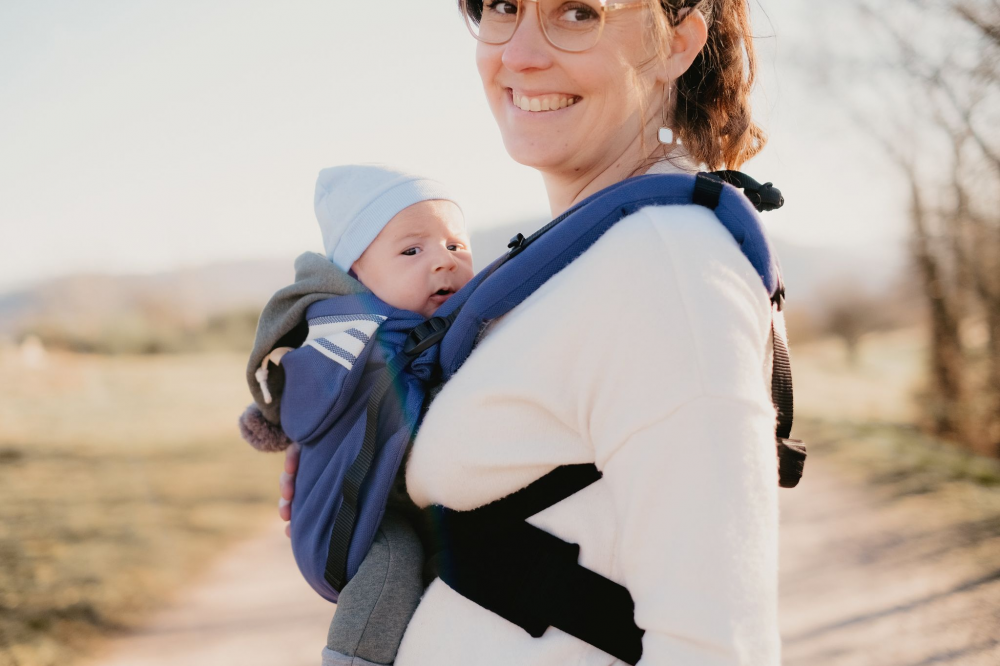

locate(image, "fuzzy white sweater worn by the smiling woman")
[[396, 196, 780, 666]]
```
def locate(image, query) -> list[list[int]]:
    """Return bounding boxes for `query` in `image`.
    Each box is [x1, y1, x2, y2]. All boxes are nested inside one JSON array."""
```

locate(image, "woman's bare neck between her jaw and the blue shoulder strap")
[[542, 127, 696, 218]]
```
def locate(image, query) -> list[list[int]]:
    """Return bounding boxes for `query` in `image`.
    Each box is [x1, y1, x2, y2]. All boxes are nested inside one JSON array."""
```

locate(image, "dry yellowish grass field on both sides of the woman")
[[0, 331, 1000, 666]]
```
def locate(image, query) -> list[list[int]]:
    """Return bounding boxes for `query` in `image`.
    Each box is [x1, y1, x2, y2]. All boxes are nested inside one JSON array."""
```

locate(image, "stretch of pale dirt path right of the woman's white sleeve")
[[781, 458, 1000, 666]]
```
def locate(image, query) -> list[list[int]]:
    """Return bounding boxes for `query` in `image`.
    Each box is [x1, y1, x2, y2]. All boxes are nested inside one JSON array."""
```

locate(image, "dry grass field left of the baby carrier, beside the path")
[[0, 349, 281, 666]]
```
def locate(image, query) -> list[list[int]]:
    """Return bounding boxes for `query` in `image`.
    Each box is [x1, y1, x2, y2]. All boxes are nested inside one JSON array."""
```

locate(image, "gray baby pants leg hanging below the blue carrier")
[[323, 509, 424, 666]]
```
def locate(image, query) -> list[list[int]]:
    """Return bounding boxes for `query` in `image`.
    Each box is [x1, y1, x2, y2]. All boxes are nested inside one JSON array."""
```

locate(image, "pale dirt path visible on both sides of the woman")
[[88, 459, 1000, 666]]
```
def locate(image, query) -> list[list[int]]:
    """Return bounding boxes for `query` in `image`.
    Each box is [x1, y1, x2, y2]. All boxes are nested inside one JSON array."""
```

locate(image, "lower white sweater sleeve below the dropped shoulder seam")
[[604, 397, 779, 666]]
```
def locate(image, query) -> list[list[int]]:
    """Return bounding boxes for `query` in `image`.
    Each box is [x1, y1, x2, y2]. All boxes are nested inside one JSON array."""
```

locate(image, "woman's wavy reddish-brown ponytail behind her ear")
[[649, 0, 767, 169]]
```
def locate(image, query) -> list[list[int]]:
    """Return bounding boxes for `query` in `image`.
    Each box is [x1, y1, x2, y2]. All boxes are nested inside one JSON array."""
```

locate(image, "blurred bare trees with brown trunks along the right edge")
[[796, 0, 1000, 455]]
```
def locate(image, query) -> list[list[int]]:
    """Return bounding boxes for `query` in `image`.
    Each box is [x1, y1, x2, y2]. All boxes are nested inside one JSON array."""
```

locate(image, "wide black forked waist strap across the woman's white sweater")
[[425, 465, 644, 664]]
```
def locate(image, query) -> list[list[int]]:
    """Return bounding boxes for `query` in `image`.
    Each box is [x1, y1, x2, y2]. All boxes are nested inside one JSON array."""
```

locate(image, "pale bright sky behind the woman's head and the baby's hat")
[[0, 0, 905, 291]]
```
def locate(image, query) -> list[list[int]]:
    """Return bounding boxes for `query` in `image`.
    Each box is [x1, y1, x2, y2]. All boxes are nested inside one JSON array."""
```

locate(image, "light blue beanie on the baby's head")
[[316, 164, 457, 271]]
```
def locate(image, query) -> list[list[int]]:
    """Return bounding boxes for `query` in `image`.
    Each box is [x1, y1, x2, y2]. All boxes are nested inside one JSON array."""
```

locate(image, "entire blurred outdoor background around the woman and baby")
[[0, 0, 1000, 666]]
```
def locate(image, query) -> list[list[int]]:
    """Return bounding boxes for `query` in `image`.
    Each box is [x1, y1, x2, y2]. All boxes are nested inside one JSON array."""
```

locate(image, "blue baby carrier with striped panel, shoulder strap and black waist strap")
[[282, 171, 805, 664]]
